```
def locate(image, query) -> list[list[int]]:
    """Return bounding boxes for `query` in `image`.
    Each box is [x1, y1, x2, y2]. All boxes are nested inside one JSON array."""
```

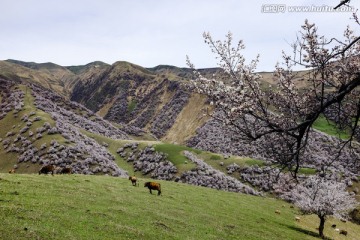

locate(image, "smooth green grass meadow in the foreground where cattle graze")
[[0, 174, 360, 240]]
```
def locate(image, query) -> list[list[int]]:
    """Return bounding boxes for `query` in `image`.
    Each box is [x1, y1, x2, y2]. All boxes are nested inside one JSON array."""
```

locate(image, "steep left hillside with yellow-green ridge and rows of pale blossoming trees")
[[0, 79, 128, 176]]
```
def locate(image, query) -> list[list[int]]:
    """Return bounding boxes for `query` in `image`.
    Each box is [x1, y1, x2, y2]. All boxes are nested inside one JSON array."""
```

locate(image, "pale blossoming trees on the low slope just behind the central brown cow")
[[117, 143, 261, 195]]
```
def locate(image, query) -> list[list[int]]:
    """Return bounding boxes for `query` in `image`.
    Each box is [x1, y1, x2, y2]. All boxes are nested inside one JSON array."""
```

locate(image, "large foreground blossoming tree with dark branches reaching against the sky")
[[187, 15, 360, 178]]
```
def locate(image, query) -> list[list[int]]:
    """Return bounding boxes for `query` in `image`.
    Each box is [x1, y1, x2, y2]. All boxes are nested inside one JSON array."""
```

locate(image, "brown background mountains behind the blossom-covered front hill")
[[0, 60, 358, 174]]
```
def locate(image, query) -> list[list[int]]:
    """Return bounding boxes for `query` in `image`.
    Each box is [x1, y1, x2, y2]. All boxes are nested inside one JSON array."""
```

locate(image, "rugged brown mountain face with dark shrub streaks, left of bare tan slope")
[[71, 62, 202, 142]]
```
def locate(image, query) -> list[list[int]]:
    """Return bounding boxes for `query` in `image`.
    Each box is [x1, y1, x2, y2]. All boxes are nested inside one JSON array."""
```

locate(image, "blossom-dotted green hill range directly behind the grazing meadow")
[[0, 76, 258, 194]]
